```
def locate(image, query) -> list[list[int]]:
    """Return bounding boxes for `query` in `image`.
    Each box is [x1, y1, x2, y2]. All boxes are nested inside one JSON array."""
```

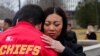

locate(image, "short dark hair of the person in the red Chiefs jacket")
[[17, 4, 43, 25]]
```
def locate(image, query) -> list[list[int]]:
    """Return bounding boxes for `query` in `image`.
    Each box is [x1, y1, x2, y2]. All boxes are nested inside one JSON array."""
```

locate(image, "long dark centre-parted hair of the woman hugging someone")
[[41, 7, 67, 40]]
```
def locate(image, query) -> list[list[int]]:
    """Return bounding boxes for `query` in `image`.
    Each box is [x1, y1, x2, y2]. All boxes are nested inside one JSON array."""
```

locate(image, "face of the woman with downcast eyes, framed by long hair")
[[44, 13, 63, 39]]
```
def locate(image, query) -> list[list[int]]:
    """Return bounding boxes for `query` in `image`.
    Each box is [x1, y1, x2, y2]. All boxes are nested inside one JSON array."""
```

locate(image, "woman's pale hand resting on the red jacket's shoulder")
[[41, 35, 65, 53]]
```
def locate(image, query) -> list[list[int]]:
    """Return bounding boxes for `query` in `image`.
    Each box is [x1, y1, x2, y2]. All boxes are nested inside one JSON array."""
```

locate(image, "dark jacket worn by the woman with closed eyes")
[[59, 38, 86, 56]]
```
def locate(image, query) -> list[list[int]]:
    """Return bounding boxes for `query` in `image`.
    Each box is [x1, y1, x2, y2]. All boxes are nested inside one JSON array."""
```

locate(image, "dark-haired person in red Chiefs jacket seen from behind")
[[0, 4, 57, 56]]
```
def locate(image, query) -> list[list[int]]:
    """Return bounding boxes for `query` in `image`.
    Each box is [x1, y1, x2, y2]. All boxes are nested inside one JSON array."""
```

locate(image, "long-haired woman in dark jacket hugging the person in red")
[[41, 7, 85, 56]]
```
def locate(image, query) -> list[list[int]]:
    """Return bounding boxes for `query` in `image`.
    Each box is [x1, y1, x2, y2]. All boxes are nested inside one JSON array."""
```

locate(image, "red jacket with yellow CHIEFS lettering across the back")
[[0, 21, 57, 56]]
